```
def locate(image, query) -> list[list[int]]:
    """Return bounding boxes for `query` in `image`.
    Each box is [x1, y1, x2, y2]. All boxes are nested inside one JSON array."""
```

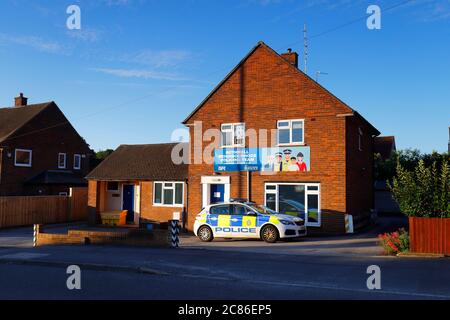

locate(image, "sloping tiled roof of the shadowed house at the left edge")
[[0, 102, 53, 142]]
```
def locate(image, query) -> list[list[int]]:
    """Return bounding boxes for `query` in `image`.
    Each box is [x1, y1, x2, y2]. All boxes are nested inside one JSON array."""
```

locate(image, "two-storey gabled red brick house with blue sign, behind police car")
[[184, 42, 379, 233]]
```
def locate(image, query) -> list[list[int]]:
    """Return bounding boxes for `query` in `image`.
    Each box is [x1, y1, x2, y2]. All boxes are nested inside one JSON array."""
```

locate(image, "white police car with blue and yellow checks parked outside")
[[194, 199, 306, 243]]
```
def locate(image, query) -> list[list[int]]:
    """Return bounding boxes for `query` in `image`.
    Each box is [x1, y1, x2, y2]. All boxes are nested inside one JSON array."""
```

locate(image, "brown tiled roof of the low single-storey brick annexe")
[[86, 143, 188, 181]]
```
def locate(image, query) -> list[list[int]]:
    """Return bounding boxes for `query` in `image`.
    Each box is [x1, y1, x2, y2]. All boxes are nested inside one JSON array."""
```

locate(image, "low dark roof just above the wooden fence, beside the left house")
[[25, 170, 87, 186]]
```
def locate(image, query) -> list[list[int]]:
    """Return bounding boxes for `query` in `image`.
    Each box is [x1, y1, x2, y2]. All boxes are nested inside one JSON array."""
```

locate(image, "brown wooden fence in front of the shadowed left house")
[[0, 188, 88, 229]]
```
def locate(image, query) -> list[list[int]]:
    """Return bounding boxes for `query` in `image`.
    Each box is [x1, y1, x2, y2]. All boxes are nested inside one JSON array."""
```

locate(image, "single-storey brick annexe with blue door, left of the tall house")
[[87, 143, 188, 224]]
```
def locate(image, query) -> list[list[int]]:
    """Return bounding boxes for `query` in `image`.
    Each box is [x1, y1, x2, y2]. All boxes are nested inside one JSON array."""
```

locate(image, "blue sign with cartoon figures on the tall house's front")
[[214, 147, 311, 173]]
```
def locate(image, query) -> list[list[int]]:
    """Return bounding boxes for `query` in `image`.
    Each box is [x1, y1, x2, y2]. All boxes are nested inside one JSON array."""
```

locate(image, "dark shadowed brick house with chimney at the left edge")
[[0, 94, 91, 196]]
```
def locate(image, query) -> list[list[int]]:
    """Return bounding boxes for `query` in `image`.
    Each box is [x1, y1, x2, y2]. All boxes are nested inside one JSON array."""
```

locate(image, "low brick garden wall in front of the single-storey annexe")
[[36, 225, 170, 247]]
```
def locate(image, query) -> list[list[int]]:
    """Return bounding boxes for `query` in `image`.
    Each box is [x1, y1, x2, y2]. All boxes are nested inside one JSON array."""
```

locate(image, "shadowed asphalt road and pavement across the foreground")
[[0, 215, 450, 300]]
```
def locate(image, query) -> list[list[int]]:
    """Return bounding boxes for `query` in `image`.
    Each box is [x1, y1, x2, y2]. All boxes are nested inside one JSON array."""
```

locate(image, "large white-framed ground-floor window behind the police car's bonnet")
[[264, 183, 322, 227]]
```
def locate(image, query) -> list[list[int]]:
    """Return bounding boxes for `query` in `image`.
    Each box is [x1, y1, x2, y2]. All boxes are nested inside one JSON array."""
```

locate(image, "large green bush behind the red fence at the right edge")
[[389, 160, 450, 218]]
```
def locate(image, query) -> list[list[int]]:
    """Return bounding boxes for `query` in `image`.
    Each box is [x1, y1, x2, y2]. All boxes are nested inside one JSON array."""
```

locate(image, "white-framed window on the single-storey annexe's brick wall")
[[153, 181, 184, 207]]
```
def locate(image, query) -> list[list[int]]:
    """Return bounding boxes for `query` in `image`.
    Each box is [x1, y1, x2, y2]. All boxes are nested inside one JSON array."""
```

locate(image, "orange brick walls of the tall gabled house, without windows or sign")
[[183, 42, 371, 232]]
